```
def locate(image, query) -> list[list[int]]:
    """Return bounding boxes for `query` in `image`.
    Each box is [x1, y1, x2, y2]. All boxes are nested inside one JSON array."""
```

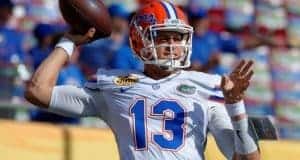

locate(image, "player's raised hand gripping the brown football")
[[64, 28, 96, 46]]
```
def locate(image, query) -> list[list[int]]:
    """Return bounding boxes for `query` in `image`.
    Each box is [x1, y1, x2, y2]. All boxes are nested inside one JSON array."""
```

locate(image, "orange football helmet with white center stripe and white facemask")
[[129, 1, 193, 69]]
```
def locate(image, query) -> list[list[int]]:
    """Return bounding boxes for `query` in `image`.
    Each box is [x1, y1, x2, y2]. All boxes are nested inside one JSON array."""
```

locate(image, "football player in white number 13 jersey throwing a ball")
[[26, 1, 260, 160]]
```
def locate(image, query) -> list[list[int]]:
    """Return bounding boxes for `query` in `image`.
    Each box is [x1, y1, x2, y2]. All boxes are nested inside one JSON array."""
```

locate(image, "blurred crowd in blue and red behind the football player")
[[0, 0, 300, 139]]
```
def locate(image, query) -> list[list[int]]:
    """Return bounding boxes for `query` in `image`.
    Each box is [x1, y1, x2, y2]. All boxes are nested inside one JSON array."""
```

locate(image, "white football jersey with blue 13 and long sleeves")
[[49, 69, 234, 160]]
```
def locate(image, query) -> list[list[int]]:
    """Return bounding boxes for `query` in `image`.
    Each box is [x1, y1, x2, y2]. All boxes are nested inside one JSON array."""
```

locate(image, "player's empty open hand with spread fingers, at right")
[[221, 60, 253, 104]]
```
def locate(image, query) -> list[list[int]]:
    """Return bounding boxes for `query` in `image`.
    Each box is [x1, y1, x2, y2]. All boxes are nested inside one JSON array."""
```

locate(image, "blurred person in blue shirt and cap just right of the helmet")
[[188, 8, 258, 74]]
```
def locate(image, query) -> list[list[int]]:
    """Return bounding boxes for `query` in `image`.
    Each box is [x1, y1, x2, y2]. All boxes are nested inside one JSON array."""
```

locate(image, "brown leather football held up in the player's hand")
[[59, 0, 112, 40]]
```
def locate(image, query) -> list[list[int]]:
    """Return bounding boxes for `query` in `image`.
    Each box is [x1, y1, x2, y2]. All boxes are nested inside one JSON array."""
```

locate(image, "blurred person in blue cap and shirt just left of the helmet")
[[79, 4, 140, 76]]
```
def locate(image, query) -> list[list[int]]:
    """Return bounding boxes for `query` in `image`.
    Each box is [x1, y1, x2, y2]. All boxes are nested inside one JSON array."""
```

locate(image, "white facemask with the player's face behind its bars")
[[139, 19, 193, 70]]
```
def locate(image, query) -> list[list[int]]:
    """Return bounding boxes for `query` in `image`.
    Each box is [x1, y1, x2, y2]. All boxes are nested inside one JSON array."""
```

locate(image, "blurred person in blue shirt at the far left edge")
[[0, 0, 30, 103]]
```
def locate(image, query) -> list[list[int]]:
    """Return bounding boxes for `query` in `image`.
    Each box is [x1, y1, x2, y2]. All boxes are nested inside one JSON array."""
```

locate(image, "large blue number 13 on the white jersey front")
[[130, 99, 185, 150]]
